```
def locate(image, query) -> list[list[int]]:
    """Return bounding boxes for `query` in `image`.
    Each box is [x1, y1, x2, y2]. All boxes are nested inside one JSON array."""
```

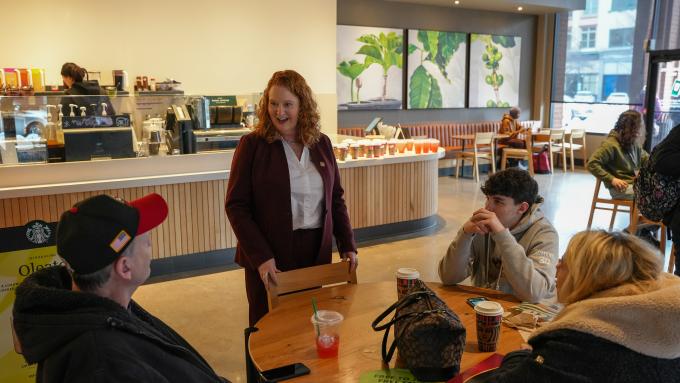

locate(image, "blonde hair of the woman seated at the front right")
[[557, 230, 662, 304]]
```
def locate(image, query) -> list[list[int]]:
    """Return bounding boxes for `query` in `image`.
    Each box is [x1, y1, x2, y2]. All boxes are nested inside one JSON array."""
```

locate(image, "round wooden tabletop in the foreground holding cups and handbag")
[[249, 282, 523, 382]]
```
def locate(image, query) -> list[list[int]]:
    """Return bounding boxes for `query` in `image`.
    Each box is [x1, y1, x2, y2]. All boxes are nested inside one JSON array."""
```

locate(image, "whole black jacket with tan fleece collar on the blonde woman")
[[488, 273, 680, 383]]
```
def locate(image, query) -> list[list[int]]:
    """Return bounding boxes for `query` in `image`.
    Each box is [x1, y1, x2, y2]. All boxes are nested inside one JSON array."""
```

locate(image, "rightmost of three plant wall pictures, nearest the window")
[[469, 33, 522, 108]]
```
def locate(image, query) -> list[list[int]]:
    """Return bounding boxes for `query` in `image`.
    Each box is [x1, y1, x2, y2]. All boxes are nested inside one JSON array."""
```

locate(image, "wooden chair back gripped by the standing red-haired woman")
[[267, 261, 357, 310]]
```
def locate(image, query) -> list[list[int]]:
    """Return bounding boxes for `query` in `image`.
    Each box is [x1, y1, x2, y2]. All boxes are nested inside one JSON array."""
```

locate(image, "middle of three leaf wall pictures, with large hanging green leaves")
[[407, 29, 467, 109]]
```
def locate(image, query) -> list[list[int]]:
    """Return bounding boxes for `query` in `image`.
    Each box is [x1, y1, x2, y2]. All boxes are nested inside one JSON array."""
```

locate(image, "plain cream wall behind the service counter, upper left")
[[0, 0, 337, 132]]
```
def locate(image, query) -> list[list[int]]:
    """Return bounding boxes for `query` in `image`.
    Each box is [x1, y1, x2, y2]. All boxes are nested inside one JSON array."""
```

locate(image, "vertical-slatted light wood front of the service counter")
[[0, 159, 438, 259]]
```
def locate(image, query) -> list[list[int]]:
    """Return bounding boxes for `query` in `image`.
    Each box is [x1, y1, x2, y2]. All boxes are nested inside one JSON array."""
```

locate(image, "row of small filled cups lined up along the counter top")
[[333, 139, 439, 161]]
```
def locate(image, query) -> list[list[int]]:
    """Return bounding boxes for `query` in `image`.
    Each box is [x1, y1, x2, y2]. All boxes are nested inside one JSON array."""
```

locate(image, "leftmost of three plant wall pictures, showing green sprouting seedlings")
[[336, 25, 404, 110]]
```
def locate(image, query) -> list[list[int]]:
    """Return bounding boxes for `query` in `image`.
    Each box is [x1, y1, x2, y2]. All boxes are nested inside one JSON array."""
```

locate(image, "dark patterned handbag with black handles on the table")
[[371, 280, 465, 382]]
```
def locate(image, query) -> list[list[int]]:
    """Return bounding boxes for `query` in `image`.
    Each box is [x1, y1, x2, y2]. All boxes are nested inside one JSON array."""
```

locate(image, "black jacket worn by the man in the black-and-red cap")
[[13, 266, 225, 383]]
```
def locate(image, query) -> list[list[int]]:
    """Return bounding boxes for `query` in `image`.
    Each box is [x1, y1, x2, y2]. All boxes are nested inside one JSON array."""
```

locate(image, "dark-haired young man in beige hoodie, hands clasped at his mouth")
[[439, 168, 559, 302]]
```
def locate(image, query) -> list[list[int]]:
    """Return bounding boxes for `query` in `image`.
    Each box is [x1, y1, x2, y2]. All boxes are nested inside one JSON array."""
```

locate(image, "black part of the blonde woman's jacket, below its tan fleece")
[[487, 330, 680, 383]]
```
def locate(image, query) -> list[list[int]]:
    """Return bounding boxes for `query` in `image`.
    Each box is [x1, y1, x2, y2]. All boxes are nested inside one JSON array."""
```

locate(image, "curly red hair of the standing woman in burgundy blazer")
[[255, 70, 321, 146]]
